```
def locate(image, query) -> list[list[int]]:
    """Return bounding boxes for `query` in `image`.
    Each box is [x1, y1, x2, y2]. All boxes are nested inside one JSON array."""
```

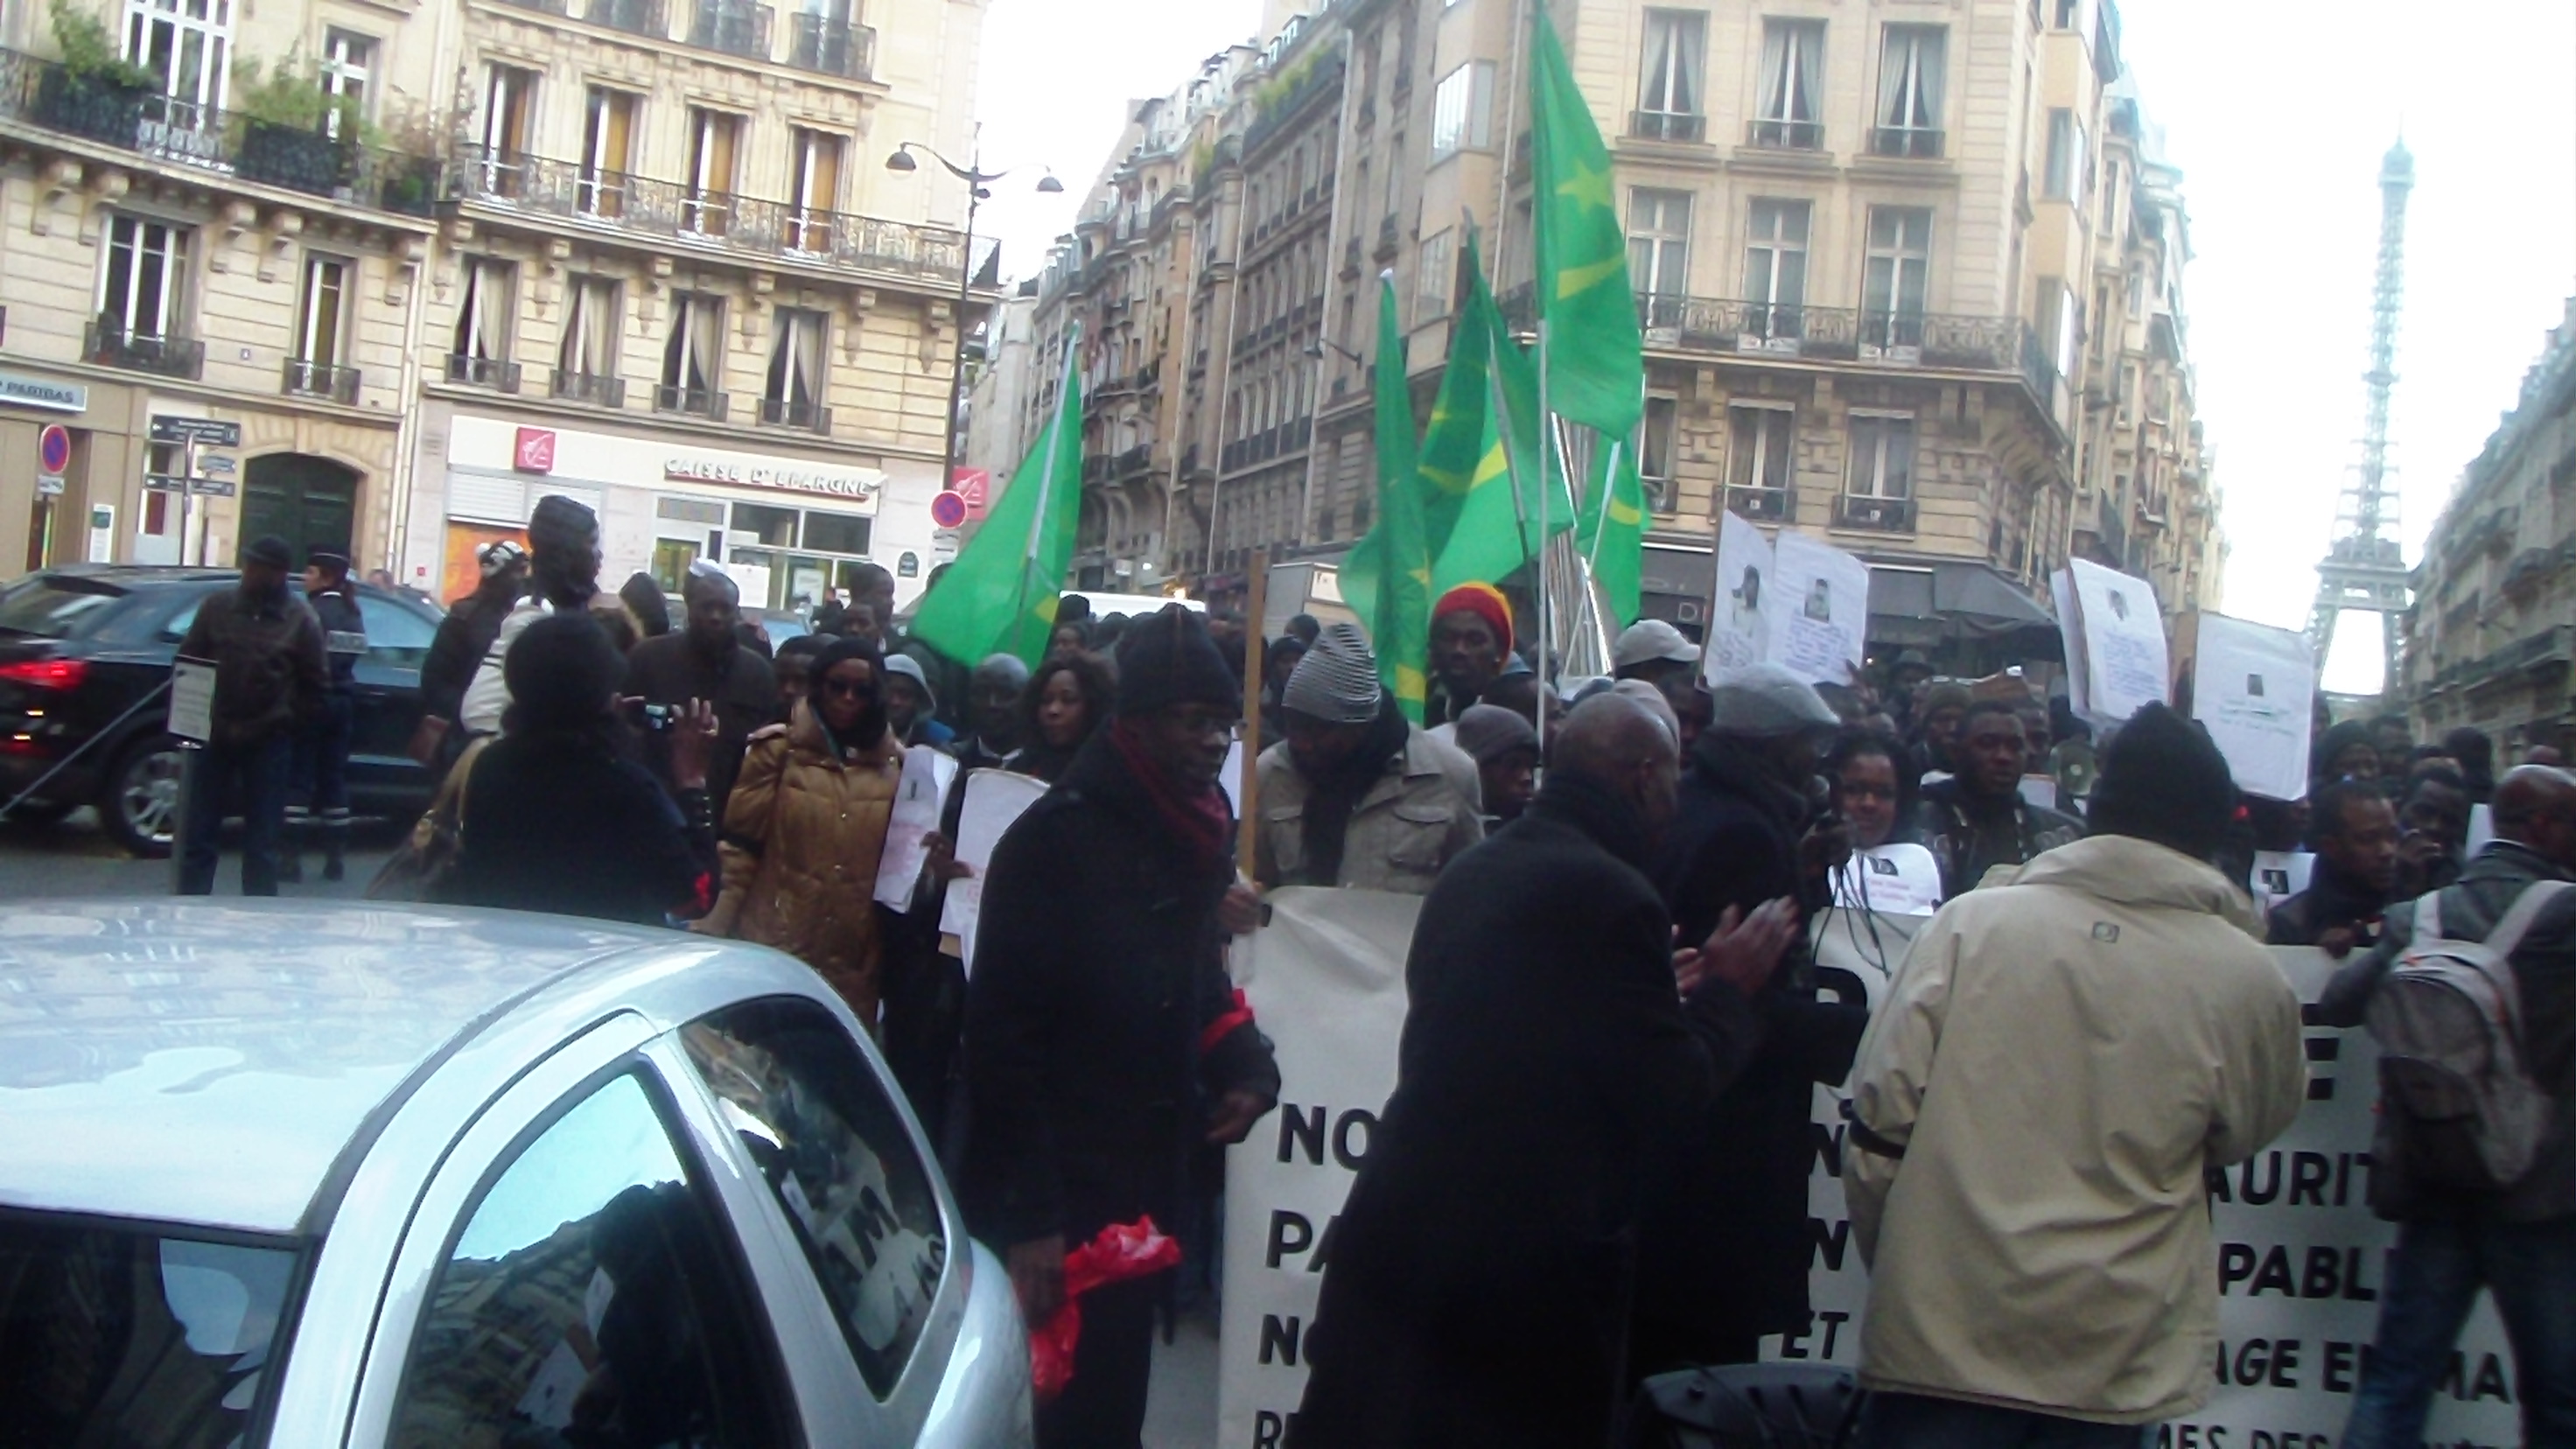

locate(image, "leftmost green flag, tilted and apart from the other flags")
[[912, 359, 1082, 665]]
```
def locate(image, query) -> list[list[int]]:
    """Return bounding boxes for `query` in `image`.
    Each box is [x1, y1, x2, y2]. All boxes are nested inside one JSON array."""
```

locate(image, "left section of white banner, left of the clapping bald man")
[[1216, 887, 1422, 1449]]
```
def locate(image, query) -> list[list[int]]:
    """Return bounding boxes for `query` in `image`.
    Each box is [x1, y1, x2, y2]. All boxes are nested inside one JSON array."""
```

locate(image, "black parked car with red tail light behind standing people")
[[0, 564, 438, 856]]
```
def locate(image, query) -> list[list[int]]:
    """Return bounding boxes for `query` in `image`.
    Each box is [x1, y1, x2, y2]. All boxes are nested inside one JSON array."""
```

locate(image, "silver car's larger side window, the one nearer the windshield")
[[387, 1073, 791, 1449]]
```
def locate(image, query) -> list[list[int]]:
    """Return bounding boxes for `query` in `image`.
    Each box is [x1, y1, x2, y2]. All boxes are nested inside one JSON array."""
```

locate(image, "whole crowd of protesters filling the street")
[[165, 513, 2576, 1449]]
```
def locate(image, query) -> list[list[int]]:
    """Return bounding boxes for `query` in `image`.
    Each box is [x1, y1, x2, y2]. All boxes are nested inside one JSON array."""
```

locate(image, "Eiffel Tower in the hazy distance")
[[2308, 139, 2414, 694]]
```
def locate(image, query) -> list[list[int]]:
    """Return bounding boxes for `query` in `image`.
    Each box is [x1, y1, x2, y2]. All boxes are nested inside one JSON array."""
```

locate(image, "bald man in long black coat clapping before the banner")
[[1288, 696, 1788, 1449]]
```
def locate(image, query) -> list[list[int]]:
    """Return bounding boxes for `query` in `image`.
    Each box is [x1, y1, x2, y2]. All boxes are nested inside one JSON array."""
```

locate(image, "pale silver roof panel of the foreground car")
[[0, 900, 716, 1232]]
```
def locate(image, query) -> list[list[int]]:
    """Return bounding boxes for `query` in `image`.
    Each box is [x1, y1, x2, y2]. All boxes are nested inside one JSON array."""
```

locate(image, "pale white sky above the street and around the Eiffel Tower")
[[982, 0, 2576, 689]]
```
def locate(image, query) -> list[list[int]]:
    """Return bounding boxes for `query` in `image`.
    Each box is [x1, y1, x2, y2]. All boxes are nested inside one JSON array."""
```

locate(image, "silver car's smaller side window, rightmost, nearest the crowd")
[[680, 998, 948, 1397]]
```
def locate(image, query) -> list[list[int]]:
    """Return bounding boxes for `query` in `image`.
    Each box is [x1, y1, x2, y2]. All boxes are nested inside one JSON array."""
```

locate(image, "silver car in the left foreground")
[[0, 900, 1031, 1449]]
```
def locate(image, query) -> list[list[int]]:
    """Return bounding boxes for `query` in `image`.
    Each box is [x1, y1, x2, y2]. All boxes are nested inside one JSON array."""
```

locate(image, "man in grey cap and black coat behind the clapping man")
[[1635, 665, 1870, 1375]]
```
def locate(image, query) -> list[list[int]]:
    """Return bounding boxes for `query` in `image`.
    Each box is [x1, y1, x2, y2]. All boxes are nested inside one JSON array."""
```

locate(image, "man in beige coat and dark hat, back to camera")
[[1844, 704, 2308, 1449]]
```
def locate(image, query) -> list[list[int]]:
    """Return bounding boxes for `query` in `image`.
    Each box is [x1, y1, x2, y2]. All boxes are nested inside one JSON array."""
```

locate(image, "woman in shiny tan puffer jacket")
[[698, 640, 904, 1015]]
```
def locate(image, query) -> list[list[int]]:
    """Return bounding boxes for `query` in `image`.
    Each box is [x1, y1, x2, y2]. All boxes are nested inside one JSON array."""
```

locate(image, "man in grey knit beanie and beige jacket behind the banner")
[[1252, 624, 1484, 894]]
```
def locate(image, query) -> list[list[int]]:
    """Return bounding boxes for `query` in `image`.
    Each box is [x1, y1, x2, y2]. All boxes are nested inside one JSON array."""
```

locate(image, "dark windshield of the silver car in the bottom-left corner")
[[0, 1212, 297, 1449]]
